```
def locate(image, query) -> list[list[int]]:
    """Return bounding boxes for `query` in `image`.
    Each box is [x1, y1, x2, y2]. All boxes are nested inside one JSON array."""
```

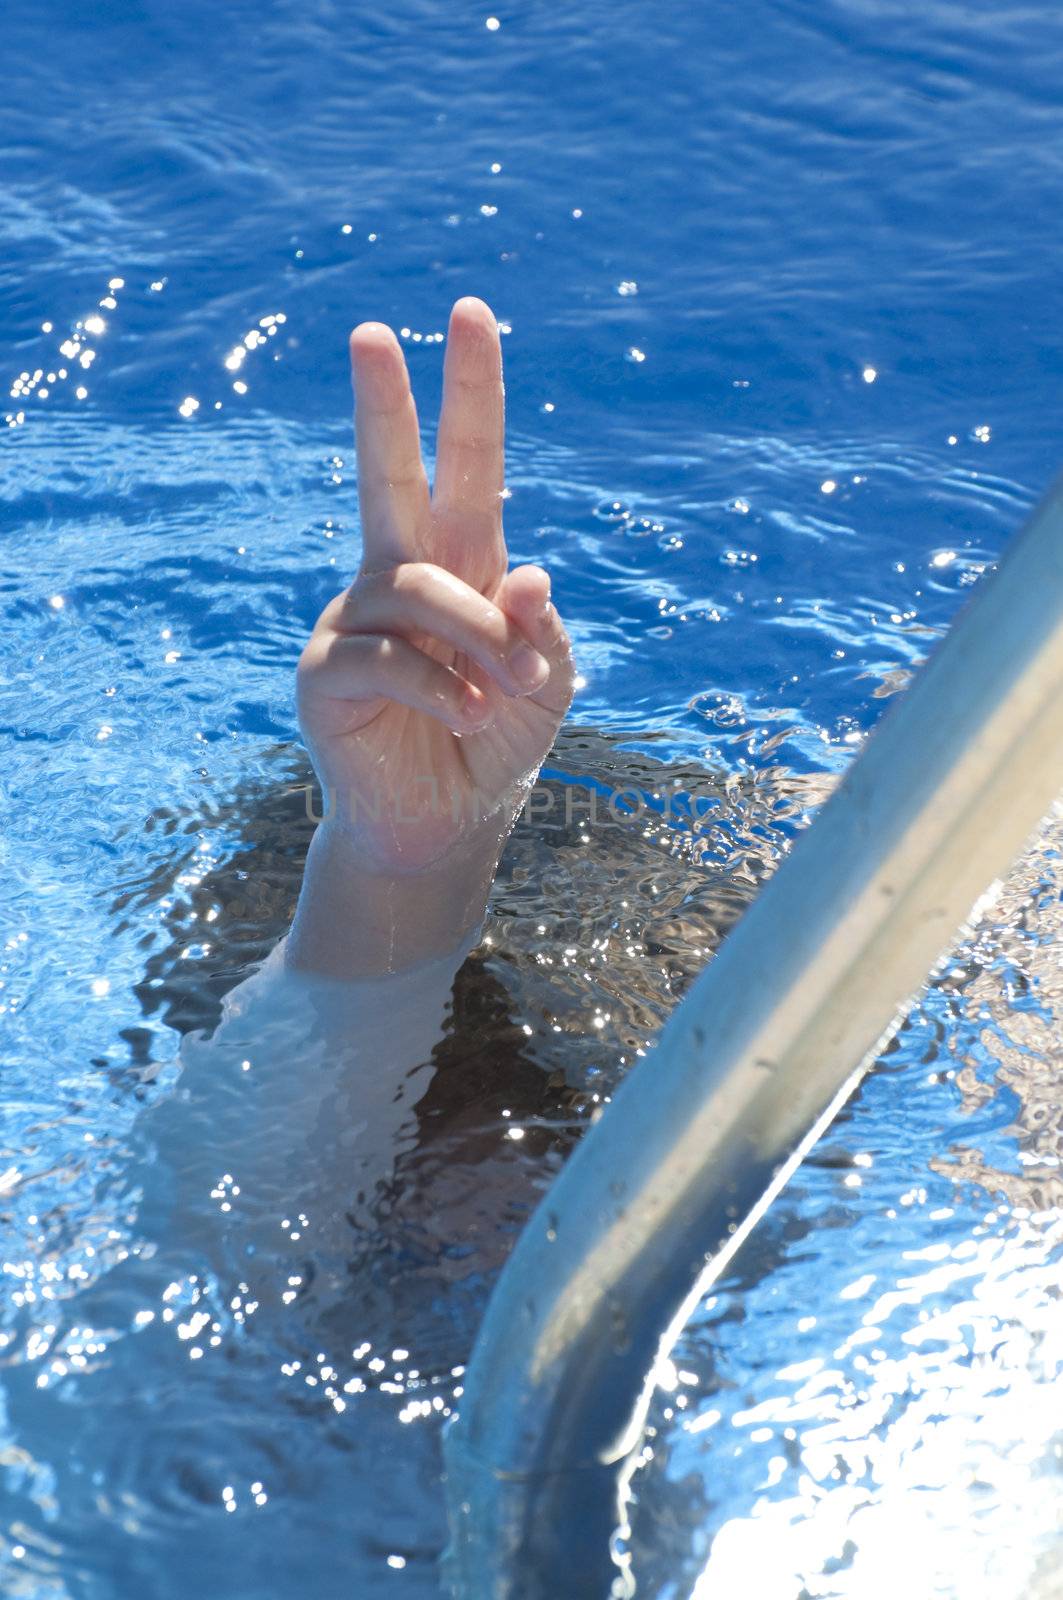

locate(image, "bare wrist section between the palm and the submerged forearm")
[[285, 819, 507, 981]]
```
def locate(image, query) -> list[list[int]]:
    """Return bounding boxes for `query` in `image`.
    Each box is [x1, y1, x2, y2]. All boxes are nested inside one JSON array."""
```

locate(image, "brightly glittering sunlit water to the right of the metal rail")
[[632, 800, 1063, 1600]]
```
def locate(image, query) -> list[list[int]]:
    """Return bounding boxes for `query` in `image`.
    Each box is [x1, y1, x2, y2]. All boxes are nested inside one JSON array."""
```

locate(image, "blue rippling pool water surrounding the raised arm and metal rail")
[[0, 0, 1063, 1600]]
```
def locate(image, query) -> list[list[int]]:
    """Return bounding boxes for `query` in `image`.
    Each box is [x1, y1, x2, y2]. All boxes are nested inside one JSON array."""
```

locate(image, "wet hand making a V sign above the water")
[[298, 298, 573, 875]]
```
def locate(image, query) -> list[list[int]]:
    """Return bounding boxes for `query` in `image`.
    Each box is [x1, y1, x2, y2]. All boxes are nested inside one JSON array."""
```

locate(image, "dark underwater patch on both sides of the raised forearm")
[[115, 728, 826, 1378]]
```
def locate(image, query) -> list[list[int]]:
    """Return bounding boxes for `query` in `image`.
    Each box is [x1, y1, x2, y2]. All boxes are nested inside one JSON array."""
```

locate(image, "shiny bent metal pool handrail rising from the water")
[[445, 467, 1063, 1600]]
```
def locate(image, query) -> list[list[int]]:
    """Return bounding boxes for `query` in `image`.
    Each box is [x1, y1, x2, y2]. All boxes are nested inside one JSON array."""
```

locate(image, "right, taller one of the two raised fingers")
[[432, 294, 506, 544]]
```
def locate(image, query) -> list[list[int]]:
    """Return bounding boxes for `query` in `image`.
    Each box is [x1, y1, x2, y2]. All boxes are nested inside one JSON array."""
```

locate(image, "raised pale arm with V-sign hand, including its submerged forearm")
[[153, 299, 573, 1260]]
